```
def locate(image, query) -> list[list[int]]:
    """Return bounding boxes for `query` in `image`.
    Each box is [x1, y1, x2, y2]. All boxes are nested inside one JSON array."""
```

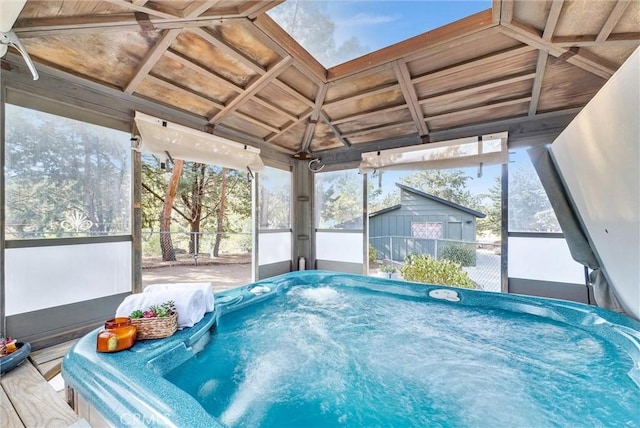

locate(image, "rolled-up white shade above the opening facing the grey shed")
[[360, 132, 508, 173]]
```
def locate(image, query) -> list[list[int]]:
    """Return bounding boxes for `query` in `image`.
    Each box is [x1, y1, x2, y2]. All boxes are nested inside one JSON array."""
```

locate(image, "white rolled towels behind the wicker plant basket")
[[116, 289, 205, 328]]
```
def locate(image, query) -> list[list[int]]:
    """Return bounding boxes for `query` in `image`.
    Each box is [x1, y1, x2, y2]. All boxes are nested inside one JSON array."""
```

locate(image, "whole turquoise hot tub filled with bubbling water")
[[63, 271, 640, 427]]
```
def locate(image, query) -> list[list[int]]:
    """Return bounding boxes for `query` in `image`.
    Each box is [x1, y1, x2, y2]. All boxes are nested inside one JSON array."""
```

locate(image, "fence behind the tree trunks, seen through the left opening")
[[141, 230, 252, 264]]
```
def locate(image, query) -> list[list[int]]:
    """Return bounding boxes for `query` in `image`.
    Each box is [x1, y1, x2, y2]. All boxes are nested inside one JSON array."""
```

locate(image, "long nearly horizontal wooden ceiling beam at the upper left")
[[13, 14, 245, 39]]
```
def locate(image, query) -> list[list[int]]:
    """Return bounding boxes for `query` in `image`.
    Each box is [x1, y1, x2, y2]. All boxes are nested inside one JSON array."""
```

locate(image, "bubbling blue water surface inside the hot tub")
[[165, 284, 640, 427]]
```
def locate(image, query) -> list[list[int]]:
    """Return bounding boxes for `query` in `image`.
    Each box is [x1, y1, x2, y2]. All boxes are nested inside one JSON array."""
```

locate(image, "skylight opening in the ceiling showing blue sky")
[[267, 0, 491, 68]]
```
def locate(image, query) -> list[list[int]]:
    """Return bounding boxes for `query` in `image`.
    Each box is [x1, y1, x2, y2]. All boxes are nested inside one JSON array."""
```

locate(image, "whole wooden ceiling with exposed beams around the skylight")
[[6, 0, 640, 163]]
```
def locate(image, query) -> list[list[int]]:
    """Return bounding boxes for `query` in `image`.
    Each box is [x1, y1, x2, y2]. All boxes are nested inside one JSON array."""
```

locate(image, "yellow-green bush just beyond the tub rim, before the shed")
[[400, 254, 476, 288]]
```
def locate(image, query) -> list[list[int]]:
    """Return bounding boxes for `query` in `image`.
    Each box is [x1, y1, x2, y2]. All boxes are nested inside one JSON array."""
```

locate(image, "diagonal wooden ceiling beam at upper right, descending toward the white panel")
[[500, 21, 616, 79]]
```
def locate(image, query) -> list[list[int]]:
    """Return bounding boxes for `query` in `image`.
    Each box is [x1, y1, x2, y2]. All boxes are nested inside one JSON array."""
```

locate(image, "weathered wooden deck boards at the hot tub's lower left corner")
[[0, 341, 90, 428]]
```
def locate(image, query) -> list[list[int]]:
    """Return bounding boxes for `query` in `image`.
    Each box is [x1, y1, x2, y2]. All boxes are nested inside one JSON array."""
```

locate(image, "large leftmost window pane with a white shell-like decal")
[[5, 104, 131, 240]]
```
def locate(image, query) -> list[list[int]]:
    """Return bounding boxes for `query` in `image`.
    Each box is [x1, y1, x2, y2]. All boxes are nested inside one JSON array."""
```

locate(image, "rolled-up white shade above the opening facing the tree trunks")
[[133, 112, 264, 172]]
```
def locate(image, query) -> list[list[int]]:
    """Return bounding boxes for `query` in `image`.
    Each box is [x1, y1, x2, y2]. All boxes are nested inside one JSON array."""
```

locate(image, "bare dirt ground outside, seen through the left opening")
[[142, 254, 251, 292]]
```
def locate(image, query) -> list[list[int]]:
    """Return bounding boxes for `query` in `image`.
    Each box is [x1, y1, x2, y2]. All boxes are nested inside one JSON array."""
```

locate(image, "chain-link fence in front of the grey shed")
[[369, 236, 501, 291]]
